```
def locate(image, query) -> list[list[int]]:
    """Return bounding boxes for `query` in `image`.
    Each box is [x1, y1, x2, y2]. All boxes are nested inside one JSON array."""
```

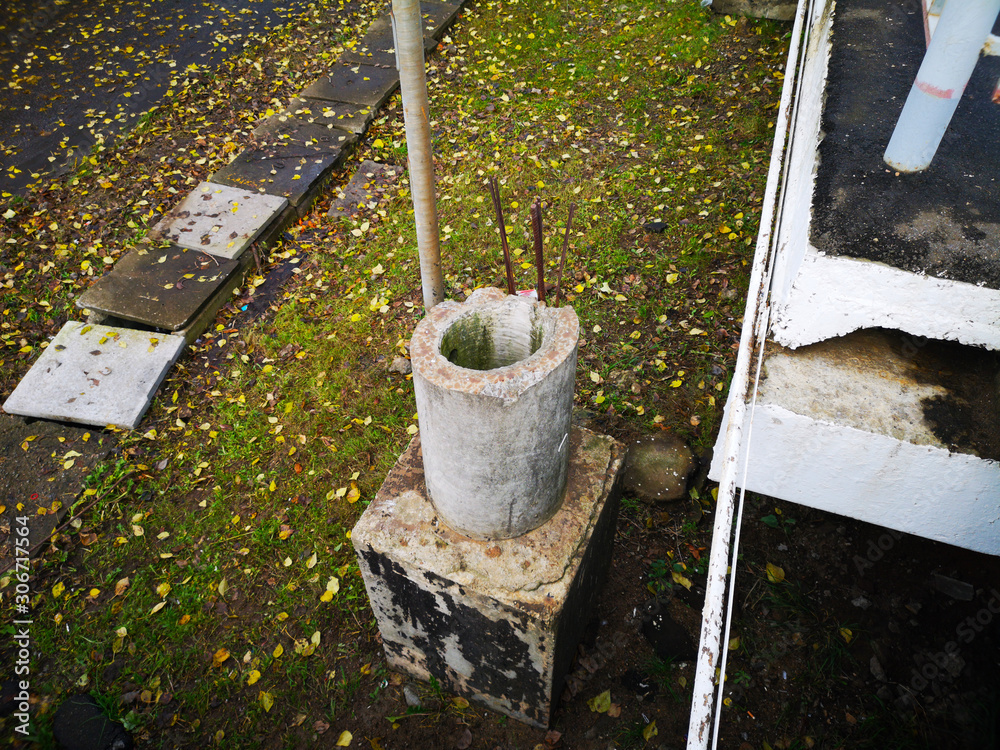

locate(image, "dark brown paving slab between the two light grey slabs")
[[76, 245, 241, 331]]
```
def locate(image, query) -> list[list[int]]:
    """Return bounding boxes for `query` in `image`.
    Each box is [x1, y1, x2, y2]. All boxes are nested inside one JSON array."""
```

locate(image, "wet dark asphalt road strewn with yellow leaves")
[[0, 0, 316, 194]]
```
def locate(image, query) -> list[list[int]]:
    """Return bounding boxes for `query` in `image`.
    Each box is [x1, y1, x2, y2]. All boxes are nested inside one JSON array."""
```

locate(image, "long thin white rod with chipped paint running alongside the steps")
[[687, 0, 811, 750]]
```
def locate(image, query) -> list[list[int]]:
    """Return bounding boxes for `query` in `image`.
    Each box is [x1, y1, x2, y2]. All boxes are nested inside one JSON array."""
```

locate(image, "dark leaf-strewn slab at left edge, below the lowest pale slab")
[[0, 414, 117, 570]]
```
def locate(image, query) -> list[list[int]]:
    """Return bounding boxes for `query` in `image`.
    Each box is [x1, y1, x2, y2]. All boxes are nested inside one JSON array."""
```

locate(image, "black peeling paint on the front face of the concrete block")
[[359, 549, 551, 725]]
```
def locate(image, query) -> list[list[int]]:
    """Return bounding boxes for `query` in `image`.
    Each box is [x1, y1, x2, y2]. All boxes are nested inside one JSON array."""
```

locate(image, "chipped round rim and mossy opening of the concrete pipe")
[[410, 288, 580, 401]]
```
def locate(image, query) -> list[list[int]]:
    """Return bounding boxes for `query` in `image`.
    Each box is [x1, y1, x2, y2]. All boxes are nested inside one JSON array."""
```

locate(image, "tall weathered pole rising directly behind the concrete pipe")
[[392, 0, 444, 310]]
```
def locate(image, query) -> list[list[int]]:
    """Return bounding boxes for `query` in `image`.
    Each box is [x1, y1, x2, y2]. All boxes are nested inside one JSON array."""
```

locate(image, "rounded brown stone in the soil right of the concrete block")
[[623, 433, 698, 501]]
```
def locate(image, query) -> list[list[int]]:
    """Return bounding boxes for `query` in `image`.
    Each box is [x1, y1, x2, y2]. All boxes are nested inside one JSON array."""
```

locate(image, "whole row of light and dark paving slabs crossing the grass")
[[3, 2, 462, 429]]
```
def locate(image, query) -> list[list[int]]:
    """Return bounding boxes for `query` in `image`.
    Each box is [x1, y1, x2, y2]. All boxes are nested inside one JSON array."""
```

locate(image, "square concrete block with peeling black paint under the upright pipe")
[[351, 427, 624, 728]]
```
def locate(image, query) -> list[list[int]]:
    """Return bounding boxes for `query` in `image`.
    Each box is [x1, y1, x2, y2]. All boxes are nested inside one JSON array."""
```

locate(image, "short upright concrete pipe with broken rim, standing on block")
[[410, 289, 580, 539]]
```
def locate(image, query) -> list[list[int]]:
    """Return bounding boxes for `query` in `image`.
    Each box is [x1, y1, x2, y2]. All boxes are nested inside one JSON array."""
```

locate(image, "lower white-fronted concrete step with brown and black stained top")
[[710, 332, 1000, 555]]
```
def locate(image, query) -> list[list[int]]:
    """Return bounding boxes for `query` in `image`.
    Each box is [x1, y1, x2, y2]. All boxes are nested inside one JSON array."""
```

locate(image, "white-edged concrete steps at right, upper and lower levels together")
[[713, 0, 1000, 554]]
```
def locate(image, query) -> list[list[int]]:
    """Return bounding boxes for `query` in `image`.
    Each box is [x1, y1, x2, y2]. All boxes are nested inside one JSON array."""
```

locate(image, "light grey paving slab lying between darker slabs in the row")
[[150, 182, 288, 258]]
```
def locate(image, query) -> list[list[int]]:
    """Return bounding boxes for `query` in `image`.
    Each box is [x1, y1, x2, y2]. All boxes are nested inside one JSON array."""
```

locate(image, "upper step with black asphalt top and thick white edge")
[[771, 0, 1000, 349]]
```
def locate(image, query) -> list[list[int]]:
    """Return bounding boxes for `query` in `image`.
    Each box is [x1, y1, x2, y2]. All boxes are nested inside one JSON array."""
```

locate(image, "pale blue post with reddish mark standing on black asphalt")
[[883, 0, 1000, 172]]
